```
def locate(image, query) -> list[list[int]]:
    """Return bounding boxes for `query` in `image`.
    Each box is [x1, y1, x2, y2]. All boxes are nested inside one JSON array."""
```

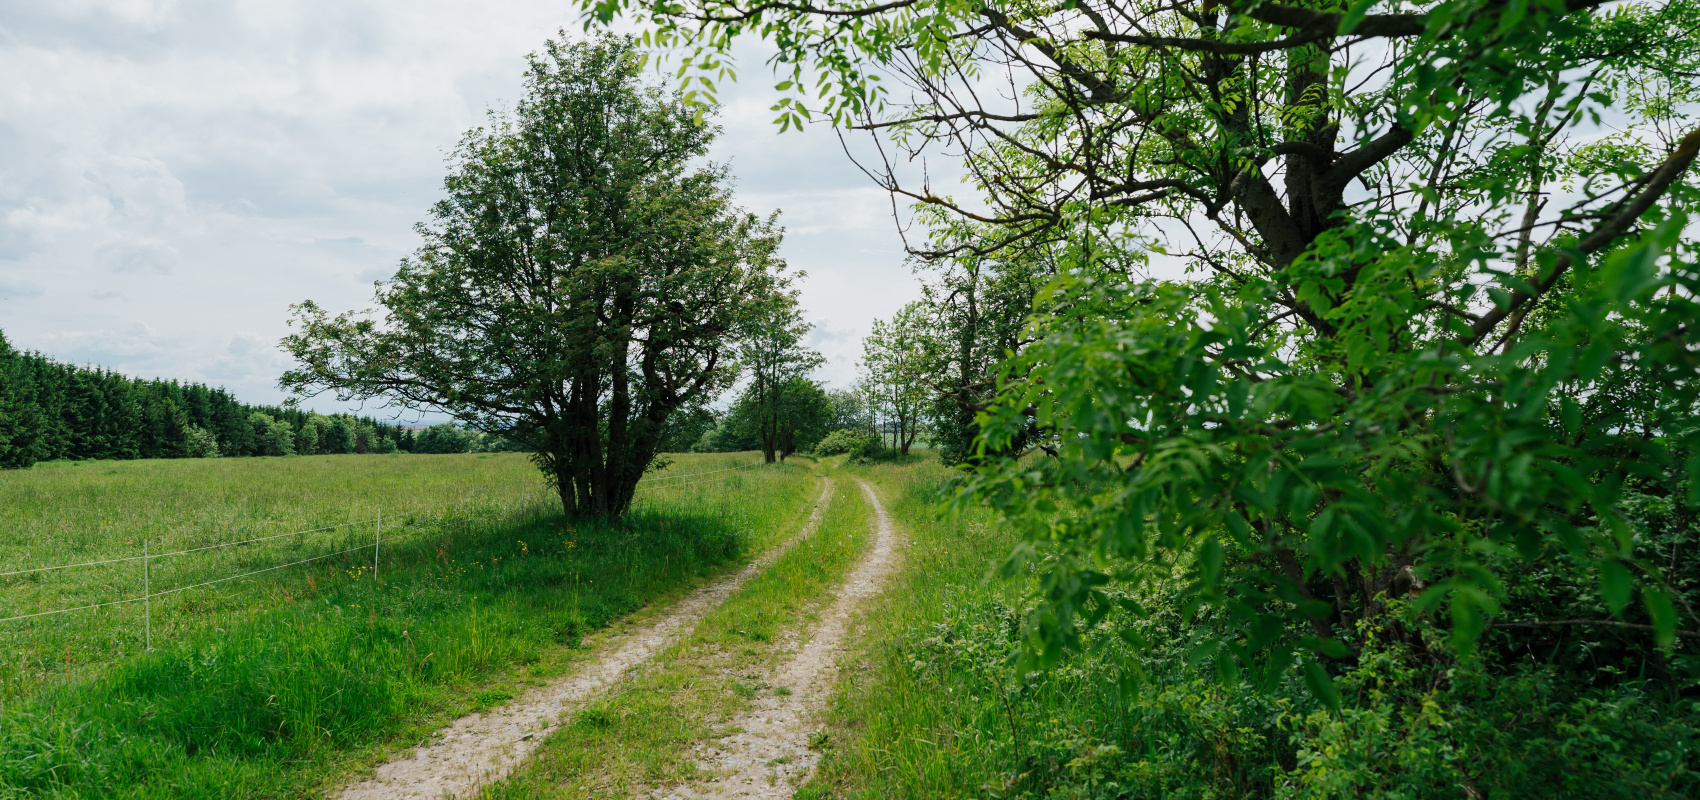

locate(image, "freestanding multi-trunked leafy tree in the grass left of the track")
[[282, 37, 794, 516]]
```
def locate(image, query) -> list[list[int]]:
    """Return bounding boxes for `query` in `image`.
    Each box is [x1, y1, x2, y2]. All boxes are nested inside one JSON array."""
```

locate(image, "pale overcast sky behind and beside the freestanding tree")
[[0, 0, 918, 419]]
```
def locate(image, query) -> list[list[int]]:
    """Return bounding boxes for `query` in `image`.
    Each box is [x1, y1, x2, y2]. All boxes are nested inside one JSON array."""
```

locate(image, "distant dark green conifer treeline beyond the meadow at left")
[[0, 333, 512, 469]]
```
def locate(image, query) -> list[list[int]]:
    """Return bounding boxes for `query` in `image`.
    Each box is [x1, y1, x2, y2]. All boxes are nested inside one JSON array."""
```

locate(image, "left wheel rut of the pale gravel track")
[[337, 479, 833, 800]]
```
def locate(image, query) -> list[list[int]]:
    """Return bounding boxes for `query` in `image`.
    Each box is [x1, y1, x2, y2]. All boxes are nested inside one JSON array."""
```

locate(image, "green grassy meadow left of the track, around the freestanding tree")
[[0, 454, 818, 798]]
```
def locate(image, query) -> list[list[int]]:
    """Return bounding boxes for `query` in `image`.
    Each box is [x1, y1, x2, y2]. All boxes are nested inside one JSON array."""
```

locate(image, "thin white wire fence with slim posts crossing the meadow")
[[0, 460, 765, 649]]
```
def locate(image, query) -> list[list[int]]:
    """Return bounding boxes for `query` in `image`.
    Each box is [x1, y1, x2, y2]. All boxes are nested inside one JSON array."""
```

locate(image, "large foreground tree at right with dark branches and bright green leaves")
[[593, 0, 1700, 682]]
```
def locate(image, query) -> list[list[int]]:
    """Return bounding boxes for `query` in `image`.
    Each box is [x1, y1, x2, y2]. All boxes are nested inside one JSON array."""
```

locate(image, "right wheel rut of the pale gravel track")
[[653, 479, 899, 800]]
